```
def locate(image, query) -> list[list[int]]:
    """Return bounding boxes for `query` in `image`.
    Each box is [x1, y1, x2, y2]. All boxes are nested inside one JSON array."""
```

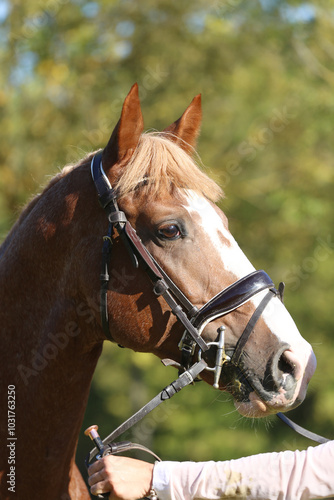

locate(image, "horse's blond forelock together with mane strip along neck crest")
[[0, 132, 223, 254]]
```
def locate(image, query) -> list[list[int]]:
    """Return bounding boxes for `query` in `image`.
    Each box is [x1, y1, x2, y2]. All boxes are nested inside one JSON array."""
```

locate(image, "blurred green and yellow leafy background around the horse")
[[0, 0, 334, 496]]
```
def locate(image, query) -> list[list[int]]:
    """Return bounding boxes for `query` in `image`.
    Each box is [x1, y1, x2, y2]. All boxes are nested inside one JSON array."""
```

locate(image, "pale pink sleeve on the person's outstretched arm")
[[153, 441, 334, 500]]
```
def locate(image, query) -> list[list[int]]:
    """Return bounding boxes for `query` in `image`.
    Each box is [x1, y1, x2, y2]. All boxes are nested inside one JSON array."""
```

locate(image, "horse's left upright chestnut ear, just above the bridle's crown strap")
[[102, 83, 144, 169]]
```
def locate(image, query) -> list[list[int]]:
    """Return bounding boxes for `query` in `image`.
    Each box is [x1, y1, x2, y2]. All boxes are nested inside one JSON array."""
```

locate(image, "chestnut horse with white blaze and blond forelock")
[[0, 84, 315, 500]]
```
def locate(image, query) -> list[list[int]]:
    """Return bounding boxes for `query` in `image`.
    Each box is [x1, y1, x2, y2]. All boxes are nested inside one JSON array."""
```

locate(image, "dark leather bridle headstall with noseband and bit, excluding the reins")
[[91, 152, 282, 378]]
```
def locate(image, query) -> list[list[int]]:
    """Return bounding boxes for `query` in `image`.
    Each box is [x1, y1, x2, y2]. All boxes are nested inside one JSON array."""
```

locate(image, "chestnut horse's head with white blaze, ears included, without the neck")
[[84, 85, 315, 417]]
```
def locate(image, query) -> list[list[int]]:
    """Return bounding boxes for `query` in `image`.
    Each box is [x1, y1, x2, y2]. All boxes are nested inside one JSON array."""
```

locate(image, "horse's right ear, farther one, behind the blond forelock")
[[164, 94, 202, 154]]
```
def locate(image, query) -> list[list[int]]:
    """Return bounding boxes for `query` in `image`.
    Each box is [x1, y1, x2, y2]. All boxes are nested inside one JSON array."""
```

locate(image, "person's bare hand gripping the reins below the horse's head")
[[88, 455, 154, 500]]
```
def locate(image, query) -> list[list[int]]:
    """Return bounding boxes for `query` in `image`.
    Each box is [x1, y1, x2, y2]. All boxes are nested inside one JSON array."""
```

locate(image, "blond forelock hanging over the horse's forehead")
[[115, 132, 223, 202]]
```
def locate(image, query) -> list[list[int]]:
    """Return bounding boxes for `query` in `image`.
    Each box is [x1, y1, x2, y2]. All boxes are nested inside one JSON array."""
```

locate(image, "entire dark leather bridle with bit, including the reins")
[[86, 151, 327, 480]]
